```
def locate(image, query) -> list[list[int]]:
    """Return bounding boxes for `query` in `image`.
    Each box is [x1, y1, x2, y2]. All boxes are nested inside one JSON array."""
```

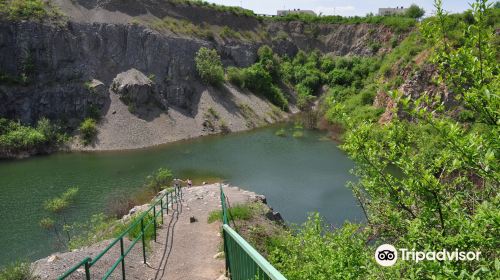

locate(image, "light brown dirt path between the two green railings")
[[147, 184, 262, 280]]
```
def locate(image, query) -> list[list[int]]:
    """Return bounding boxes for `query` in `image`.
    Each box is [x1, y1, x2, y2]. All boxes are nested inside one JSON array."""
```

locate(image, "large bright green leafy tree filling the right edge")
[[318, 0, 500, 279]]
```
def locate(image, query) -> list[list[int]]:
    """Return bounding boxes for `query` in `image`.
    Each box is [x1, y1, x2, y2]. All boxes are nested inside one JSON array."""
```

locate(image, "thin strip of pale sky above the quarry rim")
[[206, 0, 473, 16]]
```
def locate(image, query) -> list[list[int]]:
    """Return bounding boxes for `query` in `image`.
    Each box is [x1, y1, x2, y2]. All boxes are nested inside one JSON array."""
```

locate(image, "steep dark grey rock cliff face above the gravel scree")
[[0, 0, 398, 127]]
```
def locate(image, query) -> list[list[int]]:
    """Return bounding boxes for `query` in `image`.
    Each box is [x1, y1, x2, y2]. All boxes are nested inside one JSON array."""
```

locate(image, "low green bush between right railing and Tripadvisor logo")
[[268, 213, 373, 280]]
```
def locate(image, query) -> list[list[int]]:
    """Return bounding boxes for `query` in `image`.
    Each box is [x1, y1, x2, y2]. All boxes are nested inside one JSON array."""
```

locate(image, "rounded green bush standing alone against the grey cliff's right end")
[[195, 47, 224, 86]]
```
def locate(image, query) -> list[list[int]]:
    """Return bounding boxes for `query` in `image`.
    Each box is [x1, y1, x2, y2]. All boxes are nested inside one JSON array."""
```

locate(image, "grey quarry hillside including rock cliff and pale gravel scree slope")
[[0, 0, 410, 153]]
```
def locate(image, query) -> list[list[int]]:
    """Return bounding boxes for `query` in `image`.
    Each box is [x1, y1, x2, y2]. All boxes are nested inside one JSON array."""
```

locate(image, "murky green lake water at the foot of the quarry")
[[0, 124, 363, 266]]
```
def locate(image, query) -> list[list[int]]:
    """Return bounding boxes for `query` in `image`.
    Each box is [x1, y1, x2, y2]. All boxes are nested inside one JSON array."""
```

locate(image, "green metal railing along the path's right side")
[[220, 186, 286, 280]]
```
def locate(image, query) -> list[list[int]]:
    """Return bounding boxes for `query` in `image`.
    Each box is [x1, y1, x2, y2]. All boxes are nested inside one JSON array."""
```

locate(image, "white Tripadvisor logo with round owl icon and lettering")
[[375, 244, 481, 266]]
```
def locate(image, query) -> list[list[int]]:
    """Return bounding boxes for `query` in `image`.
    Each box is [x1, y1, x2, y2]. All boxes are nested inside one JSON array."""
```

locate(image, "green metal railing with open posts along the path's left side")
[[58, 187, 182, 280]]
